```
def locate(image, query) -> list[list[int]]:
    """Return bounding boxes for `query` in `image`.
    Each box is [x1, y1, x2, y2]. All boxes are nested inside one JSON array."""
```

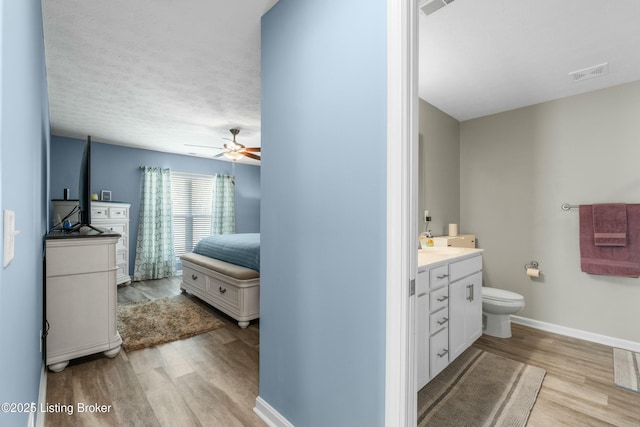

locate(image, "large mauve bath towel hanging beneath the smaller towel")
[[580, 204, 640, 277]]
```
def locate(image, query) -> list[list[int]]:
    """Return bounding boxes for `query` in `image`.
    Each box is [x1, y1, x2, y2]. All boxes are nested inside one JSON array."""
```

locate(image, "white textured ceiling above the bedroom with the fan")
[[42, 0, 277, 163]]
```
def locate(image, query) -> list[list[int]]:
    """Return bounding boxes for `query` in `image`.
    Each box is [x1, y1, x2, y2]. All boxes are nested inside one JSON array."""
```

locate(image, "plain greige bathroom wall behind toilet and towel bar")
[[460, 82, 640, 342]]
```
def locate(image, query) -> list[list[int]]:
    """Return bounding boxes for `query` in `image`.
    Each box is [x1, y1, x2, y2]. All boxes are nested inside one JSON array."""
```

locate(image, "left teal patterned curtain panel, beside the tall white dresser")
[[133, 166, 177, 280]]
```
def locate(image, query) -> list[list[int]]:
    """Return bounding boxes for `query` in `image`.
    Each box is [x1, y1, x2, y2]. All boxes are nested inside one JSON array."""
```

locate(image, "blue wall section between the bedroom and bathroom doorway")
[[260, 0, 387, 427]]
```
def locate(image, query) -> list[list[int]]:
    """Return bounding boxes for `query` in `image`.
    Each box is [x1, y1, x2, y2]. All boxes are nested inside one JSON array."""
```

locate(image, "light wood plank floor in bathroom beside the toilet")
[[474, 324, 640, 427]]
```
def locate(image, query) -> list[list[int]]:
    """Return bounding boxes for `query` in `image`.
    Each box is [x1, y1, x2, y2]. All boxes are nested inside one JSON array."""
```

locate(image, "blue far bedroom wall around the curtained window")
[[49, 135, 260, 274]]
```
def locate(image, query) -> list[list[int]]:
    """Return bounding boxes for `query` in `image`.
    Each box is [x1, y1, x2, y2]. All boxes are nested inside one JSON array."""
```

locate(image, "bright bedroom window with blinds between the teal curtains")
[[171, 171, 214, 258]]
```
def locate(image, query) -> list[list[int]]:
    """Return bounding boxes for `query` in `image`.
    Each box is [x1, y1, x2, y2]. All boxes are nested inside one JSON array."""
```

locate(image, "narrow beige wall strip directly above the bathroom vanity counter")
[[418, 99, 458, 236]]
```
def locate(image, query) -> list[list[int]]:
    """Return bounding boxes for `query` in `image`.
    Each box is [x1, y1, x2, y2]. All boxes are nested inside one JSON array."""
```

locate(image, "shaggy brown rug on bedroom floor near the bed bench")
[[118, 294, 224, 351]]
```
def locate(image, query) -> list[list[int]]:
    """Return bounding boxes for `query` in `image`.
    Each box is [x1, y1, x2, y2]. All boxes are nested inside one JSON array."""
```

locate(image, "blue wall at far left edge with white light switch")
[[0, 0, 49, 426]]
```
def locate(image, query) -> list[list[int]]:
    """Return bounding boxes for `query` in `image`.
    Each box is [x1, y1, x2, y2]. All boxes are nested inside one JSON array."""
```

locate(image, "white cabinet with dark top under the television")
[[45, 231, 122, 372]]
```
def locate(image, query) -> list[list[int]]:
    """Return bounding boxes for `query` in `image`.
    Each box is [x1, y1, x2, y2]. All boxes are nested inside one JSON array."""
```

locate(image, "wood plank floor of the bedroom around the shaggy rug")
[[45, 278, 266, 427]]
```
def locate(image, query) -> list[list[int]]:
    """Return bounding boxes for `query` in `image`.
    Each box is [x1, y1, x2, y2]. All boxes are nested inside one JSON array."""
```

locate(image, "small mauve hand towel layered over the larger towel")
[[592, 203, 627, 246]]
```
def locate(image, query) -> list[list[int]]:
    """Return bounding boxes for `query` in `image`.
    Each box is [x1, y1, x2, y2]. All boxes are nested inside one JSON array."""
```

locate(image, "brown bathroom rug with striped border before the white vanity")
[[418, 347, 546, 427]]
